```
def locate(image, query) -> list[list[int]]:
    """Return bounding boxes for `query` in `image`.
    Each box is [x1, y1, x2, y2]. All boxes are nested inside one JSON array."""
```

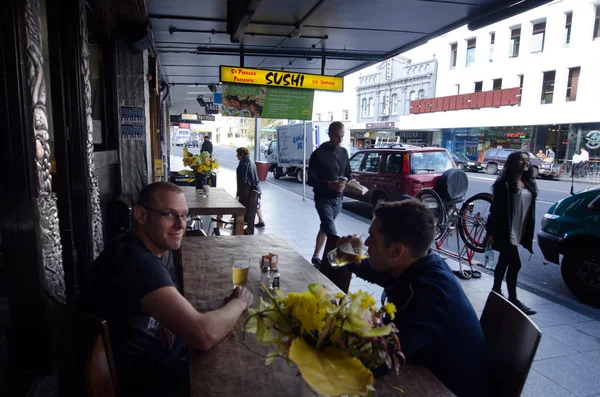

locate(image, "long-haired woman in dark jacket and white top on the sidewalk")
[[486, 151, 537, 315]]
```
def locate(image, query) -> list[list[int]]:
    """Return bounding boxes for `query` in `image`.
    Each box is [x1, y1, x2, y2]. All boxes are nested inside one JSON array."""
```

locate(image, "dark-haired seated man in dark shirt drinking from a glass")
[[338, 199, 487, 397]]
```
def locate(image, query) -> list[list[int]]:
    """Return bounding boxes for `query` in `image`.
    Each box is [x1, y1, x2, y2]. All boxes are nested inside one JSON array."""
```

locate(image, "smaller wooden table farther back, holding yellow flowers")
[[181, 186, 246, 236]]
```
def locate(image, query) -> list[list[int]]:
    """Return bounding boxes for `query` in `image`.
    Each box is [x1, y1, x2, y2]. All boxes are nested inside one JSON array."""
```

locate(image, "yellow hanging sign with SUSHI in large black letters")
[[219, 66, 344, 92]]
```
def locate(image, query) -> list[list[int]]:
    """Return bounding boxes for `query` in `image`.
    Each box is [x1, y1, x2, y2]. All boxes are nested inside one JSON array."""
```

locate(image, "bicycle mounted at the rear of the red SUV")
[[415, 169, 492, 279]]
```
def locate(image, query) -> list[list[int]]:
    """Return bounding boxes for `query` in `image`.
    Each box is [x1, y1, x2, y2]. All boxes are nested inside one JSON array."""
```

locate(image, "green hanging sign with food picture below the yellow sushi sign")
[[221, 84, 315, 120]]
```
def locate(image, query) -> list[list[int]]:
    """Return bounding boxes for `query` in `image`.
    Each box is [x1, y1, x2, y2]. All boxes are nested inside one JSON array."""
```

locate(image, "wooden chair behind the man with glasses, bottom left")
[[41, 288, 118, 397]]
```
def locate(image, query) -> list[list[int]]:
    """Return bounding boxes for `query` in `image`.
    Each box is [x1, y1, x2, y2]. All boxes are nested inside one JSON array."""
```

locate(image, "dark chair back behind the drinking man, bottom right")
[[480, 291, 542, 397]]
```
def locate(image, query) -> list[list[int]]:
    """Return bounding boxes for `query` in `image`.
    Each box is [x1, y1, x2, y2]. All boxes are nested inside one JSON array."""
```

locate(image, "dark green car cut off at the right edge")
[[537, 186, 600, 306]]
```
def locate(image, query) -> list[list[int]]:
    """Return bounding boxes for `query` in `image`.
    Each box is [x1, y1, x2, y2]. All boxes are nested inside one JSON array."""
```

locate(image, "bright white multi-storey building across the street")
[[398, 0, 600, 160]]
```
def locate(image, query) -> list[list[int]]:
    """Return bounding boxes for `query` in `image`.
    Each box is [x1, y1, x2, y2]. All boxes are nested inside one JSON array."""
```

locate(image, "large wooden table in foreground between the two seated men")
[[182, 235, 452, 397]]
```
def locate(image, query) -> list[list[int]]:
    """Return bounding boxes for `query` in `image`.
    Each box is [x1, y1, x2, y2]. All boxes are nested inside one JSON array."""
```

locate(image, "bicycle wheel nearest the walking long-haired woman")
[[458, 193, 492, 253]]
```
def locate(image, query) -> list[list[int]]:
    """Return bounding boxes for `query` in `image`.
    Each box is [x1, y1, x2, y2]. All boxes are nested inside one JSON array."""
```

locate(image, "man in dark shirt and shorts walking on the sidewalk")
[[307, 121, 352, 268]]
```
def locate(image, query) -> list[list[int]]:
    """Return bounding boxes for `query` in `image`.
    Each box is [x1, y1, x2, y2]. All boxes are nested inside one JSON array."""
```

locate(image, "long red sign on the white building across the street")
[[410, 87, 521, 114]]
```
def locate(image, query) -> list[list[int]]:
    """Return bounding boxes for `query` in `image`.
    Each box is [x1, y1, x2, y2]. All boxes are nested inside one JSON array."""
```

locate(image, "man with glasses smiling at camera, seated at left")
[[82, 182, 253, 396]]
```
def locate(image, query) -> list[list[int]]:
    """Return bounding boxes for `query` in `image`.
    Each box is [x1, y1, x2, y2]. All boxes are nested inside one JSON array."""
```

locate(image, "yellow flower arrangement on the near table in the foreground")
[[245, 284, 404, 396]]
